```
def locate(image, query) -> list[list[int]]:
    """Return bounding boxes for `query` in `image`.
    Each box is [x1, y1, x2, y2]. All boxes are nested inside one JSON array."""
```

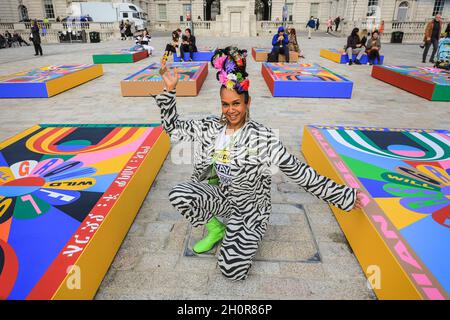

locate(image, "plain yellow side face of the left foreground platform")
[[52, 132, 170, 300]]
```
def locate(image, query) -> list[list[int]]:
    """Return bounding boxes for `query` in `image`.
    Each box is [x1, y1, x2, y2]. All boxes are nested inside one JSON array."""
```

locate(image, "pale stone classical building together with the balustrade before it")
[[0, 0, 450, 42]]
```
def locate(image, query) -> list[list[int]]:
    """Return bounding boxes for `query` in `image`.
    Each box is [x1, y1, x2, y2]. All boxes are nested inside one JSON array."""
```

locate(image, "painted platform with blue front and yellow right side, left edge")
[[0, 64, 103, 98]]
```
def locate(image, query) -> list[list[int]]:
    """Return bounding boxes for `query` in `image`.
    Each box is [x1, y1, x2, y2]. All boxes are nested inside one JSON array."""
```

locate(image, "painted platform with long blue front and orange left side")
[[262, 63, 353, 98]]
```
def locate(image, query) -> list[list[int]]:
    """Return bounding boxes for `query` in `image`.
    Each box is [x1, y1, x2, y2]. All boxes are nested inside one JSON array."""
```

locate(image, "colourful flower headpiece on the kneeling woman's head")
[[211, 47, 250, 94]]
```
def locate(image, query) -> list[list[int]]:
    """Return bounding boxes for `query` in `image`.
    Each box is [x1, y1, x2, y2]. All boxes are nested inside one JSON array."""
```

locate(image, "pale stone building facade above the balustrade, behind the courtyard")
[[0, 0, 450, 27]]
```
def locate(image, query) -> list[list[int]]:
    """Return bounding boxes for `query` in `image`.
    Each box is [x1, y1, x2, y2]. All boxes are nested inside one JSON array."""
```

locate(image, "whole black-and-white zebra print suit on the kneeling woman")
[[153, 90, 356, 280]]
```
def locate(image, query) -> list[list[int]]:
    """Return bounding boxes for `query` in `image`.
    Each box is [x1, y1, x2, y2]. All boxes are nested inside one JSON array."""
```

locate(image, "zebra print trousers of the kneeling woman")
[[169, 182, 268, 280]]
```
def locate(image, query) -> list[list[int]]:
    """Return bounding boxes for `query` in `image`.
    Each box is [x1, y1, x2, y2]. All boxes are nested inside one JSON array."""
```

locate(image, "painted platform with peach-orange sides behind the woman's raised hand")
[[120, 62, 208, 97]]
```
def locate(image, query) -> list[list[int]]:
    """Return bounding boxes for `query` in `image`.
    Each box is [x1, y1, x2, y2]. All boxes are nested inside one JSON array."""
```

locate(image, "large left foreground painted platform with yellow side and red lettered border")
[[0, 124, 170, 299]]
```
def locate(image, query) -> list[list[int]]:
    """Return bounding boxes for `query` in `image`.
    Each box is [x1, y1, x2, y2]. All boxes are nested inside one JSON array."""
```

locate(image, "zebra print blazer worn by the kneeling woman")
[[153, 90, 357, 215]]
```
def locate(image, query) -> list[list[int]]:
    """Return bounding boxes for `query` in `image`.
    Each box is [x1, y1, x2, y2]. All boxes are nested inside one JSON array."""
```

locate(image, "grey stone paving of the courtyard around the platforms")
[[0, 34, 450, 299]]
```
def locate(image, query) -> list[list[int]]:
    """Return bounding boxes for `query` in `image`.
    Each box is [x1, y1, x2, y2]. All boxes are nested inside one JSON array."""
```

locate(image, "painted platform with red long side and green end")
[[372, 65, 450, 101]]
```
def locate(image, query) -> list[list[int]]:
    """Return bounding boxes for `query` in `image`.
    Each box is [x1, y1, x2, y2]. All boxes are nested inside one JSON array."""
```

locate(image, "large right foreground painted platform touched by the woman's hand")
[[303, 126, 450, 299]]
